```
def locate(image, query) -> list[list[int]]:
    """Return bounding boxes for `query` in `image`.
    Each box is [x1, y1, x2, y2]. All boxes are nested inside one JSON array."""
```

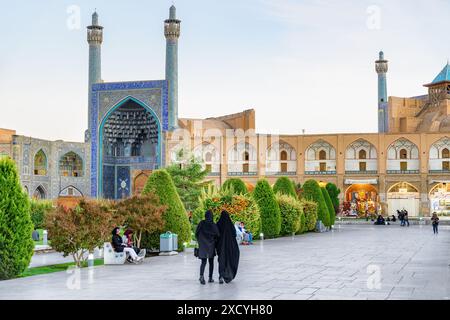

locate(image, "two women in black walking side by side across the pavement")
[[195, 210, 241, 285]]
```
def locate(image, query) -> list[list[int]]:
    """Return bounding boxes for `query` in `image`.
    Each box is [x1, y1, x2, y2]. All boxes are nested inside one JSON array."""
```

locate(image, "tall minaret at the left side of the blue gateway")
[[85, 12, 103, 141]]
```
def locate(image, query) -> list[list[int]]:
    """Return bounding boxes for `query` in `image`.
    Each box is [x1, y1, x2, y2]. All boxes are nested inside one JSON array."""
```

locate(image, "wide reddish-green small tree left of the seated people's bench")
[[45, 199, 115, 267]]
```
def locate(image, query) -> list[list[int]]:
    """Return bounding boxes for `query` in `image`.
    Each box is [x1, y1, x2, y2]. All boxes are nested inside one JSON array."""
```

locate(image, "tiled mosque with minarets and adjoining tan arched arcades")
[[0, 6, 450, 216]]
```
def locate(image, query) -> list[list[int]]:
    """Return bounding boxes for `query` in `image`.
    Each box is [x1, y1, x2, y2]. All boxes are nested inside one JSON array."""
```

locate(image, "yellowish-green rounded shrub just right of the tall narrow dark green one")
[[276, 193, 305, 235]]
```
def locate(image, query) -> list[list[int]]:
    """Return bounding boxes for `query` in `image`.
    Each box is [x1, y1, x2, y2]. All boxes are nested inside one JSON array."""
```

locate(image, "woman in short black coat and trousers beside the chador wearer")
[[195, 210, 220, 284]]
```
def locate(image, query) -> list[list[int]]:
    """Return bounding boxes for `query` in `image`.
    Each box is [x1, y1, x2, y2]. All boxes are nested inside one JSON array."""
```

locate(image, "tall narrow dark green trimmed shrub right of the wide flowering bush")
[[252, 179, 281, 238]]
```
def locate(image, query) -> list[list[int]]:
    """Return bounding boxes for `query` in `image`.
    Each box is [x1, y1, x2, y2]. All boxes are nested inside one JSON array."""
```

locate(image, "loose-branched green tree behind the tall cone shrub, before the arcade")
[[166, 156, 211, 211]]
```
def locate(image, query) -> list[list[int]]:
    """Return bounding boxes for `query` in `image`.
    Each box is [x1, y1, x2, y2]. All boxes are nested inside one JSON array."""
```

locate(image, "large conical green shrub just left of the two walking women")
[[142, 169, 191, 250]]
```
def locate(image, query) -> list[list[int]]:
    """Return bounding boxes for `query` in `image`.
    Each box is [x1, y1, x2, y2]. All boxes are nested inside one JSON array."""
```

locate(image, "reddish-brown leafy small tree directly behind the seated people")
[[115, 193, 167, 248]]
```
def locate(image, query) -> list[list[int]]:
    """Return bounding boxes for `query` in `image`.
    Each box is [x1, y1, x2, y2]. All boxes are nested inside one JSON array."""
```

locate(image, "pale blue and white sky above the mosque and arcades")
[[0, 0, 450, 141]]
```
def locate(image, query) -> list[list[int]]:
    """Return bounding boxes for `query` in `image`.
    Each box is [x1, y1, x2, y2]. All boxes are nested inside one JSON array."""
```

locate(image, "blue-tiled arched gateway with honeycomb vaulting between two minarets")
[[91, 81, 168, 199]]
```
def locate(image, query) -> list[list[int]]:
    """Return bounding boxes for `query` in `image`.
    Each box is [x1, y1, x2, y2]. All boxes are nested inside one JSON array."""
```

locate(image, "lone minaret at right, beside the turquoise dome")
[[375, 51, 388, 133]]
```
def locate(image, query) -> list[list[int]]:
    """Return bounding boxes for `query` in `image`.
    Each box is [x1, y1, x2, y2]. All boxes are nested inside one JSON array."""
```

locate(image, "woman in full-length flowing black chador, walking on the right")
[[217, 211, 239, 283]]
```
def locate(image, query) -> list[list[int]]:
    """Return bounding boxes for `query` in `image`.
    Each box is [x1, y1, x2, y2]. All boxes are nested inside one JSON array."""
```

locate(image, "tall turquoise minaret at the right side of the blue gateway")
[[164, 6, 181, 130]]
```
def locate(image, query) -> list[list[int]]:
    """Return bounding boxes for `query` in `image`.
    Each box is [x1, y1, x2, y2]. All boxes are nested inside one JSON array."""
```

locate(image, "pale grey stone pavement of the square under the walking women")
[[0, 225, 450, 300]]
